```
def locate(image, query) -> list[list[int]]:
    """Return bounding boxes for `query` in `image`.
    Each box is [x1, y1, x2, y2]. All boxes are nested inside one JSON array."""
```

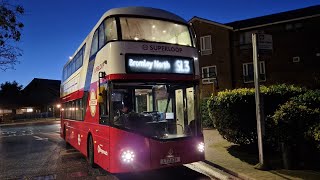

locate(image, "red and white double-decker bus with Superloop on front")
[[60, 7, 204, 173]]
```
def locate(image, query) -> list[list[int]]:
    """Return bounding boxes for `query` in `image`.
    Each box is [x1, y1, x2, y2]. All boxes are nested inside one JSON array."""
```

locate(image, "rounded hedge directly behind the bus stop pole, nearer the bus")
[[208, 84, 306, 145]]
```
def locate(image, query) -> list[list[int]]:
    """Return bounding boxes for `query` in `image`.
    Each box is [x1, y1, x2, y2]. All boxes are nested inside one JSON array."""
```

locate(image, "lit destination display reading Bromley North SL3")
[[126, 54, 193, 74]]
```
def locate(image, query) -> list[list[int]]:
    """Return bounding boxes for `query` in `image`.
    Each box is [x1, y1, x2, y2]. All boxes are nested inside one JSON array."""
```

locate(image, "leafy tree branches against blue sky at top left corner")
[[0, 0, 24, 71]]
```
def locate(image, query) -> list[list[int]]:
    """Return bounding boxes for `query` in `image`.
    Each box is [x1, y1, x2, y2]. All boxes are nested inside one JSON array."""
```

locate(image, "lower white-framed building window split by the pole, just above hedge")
[[242, 61, 266, 83]]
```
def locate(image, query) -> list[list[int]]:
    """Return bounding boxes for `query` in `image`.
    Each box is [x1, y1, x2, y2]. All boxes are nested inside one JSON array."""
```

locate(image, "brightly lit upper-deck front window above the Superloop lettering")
[[120, 17, 192, 46]]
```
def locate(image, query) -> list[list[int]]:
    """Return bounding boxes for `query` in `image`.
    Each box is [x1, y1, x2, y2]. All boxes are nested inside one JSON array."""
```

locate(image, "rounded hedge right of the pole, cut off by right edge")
[[272, 90, 320, 148]]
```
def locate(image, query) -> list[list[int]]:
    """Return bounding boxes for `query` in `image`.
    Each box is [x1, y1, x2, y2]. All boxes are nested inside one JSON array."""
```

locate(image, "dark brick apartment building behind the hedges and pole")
[[189, 5, 320, 97]]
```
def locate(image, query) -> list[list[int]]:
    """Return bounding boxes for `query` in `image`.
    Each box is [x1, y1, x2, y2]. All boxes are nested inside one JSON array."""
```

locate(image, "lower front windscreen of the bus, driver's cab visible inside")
[[111, 83, 197, 139]]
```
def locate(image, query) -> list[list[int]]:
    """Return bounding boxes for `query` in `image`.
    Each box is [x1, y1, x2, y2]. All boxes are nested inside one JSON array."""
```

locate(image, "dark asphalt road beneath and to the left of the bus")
[[0, 124, 212, 180]]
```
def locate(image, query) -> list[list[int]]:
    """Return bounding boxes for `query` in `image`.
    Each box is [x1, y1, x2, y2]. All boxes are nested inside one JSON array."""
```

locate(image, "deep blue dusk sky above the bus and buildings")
[[0, 0, 320, 86]]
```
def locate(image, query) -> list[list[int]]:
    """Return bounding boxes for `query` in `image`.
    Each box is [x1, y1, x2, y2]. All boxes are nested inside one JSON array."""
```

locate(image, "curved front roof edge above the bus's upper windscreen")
[[103, 7, 187, 24]]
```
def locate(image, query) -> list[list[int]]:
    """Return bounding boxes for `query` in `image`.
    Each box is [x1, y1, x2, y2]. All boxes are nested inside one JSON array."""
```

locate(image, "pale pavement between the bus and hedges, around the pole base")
[[204, 129, 320, 180]]
